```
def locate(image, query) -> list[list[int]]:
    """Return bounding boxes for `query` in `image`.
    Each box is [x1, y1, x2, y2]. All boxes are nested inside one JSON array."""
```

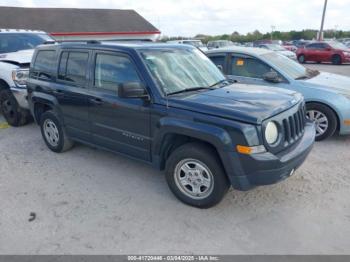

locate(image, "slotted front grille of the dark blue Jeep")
[[282, 106, 306, 147]]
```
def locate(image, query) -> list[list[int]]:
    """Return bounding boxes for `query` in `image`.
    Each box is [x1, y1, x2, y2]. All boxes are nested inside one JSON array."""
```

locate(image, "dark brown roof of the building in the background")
[[0, 7, 160, 35]]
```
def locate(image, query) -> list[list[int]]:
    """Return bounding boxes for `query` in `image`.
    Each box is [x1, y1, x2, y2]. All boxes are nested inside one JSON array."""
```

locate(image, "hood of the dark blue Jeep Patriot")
[[169, 84, 302, 124]]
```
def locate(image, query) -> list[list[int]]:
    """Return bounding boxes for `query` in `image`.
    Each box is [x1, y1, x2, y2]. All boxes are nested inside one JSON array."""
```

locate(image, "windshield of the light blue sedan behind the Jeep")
[[261, 52, 317, 79]]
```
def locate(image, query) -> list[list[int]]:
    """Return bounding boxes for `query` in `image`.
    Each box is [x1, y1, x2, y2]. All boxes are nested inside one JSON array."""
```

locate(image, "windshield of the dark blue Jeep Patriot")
[[141, 49, 225, 94]]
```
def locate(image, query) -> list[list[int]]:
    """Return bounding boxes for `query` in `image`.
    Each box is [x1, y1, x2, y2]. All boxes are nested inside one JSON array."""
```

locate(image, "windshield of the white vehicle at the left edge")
[[0, 33, 52, 53]]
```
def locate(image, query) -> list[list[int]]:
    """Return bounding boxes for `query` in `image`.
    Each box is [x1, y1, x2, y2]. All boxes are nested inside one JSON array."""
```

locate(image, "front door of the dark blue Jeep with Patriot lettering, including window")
[[89, 52, 151, 161]]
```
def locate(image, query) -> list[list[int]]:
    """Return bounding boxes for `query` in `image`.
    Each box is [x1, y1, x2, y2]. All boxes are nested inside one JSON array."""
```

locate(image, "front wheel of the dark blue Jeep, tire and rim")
[[166, 143, 229, 208]]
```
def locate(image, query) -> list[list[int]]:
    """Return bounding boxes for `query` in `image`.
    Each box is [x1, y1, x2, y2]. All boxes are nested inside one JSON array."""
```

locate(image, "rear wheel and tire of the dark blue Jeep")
[[40, 111, 73, 153]]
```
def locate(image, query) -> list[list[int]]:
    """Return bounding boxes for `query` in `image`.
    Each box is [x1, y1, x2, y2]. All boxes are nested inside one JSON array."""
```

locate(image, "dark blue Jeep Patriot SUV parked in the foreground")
[[28, 42, 315, 208]]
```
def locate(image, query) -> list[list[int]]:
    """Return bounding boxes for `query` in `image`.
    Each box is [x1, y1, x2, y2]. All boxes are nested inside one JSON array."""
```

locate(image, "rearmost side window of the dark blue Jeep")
[[33, 50, 55, 79]]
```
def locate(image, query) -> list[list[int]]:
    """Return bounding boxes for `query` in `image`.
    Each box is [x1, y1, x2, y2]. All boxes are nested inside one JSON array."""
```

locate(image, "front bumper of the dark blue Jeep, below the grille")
[[223, 122, 316, 190]]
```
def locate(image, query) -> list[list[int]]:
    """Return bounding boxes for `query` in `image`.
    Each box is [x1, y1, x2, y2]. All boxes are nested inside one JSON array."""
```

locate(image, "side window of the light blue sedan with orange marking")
[[231, 56, 271, 79]]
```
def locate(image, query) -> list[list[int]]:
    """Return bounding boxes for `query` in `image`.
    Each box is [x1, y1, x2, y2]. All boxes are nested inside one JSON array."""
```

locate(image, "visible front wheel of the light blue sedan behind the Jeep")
[[306, 103, 338, 141]]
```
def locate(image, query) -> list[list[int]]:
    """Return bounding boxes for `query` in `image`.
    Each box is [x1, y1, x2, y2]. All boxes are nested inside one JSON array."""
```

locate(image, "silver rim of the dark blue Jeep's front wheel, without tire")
[[174, 159, 214, 199]]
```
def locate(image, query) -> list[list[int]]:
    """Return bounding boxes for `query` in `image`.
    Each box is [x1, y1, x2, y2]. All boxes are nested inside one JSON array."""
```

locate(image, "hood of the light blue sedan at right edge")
[[302, 72, 350, 95]]
